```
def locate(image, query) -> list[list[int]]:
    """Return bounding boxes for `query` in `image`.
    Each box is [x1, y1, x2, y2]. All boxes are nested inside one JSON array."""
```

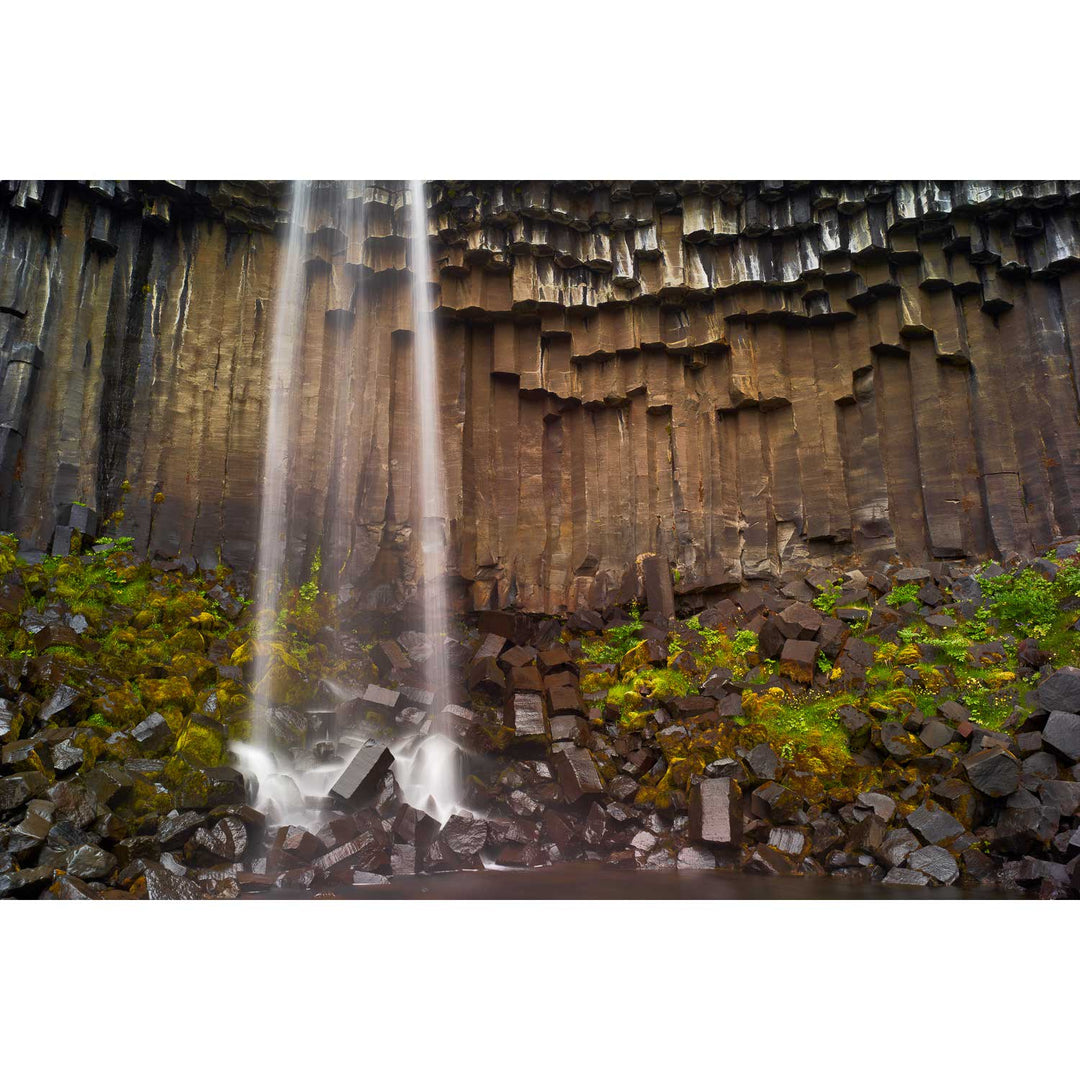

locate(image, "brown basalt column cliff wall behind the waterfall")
[[6, 181, 1080, 613]]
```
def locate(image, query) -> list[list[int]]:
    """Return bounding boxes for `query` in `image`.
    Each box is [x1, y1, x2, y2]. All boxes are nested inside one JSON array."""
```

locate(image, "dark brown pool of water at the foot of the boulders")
[[249, 863, 1022, 900]]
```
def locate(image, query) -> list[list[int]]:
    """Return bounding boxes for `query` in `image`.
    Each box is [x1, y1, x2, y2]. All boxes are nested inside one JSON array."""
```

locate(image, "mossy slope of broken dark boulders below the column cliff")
[[0, 534, 1080, 899]]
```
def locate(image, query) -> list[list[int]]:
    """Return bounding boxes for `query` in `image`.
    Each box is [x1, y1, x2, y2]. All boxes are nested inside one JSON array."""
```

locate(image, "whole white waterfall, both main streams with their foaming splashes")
[[232, 180, 461, 827]]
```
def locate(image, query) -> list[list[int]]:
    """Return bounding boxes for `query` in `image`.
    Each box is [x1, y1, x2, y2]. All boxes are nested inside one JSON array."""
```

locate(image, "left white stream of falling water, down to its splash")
[[252, 180, 311, 746]]
